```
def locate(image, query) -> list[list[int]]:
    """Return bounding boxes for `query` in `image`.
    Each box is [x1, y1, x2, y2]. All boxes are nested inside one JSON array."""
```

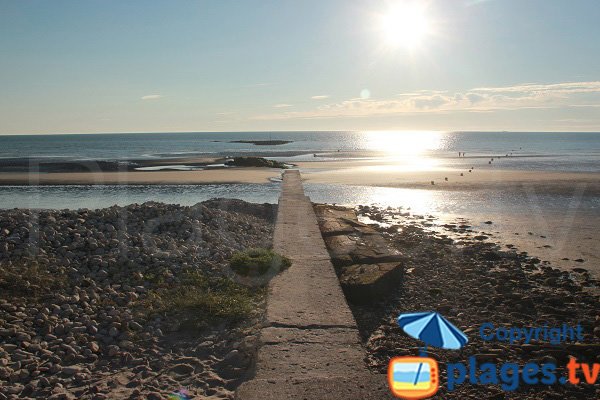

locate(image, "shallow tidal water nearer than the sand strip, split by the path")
[[0, 183, 600, 215]]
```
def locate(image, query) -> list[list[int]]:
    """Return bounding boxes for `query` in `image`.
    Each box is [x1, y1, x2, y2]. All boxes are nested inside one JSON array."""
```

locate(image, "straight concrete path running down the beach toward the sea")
[[236, 171, 391, 400]]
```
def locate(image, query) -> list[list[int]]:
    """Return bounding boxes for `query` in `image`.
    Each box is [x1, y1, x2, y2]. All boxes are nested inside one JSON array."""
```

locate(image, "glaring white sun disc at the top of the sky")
[[380, 2, 432, 50]]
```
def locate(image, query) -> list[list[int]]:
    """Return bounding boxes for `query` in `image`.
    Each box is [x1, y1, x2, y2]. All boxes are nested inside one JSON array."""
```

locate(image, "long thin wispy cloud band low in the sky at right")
[[255, 81, 600, 120]]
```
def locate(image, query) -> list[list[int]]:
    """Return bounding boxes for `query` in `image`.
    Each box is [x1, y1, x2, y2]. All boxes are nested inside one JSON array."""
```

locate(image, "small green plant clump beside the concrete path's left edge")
[[230, 249, 292, 277]]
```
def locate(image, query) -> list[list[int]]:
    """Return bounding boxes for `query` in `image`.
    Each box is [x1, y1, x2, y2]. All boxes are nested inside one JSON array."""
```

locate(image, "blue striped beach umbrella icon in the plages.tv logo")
[[398, 312, 469, 350]]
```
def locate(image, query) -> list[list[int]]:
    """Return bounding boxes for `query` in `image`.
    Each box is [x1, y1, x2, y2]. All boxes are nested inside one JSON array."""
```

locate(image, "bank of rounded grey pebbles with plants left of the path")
[[0, 199, 275, 399]]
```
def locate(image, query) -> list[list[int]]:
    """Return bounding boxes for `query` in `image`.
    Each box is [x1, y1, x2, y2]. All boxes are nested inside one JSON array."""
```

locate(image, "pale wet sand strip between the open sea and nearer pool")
[[0, 158, 600, 195]]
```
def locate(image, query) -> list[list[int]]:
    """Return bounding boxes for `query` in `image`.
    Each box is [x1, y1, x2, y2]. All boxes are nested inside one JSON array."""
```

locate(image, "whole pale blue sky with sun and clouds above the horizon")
[[0, 0, 600, 134]]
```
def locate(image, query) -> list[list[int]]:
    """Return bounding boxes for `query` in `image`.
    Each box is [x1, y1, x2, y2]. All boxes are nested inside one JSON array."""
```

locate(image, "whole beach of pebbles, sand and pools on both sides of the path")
[[0, 135, 600, 400]]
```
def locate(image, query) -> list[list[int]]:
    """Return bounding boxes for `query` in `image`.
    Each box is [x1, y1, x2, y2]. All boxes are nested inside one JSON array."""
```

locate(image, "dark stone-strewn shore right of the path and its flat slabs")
[[340, 206, 600, 399]]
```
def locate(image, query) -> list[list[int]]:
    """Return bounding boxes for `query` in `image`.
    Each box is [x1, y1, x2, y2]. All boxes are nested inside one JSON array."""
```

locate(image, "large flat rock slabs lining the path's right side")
[[314, 204, 403, 304]]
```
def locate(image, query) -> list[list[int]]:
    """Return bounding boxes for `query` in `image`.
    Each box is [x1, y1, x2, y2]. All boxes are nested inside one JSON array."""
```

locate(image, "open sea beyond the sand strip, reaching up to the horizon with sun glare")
[[0, 131, 600, 172]]
